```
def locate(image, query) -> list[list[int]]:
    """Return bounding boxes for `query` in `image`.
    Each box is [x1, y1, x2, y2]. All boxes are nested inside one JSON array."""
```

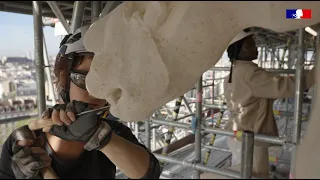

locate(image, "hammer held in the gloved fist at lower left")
[[13, 126, 59, 179]]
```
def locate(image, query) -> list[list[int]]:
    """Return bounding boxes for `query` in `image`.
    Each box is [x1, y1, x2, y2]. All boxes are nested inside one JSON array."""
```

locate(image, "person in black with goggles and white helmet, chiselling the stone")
[[0, 27, 160, 179]]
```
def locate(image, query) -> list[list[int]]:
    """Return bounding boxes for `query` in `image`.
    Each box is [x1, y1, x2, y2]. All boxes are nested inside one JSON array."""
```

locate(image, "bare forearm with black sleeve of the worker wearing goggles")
[[100, 121, 160, 179]]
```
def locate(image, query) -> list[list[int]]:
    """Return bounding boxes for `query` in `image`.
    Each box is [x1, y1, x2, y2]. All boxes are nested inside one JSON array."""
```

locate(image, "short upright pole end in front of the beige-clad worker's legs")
[[240, 131, 254, 179]]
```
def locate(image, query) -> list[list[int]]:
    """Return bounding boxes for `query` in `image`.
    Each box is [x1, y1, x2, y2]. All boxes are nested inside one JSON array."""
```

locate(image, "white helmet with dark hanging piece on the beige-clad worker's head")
[[227, 31, 254, 83]]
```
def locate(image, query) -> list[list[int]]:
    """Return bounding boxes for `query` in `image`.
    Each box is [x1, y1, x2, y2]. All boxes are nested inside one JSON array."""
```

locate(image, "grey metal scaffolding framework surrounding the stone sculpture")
[[1, 1, 320, 179]]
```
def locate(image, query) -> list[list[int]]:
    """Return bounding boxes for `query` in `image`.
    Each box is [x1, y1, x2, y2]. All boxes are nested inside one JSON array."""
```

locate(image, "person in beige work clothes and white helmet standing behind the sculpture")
[[224, 31, 315, 178]]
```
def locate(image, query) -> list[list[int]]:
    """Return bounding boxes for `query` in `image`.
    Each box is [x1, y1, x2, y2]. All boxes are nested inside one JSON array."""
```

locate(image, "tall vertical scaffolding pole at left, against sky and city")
[[32, 1, 46, 117]]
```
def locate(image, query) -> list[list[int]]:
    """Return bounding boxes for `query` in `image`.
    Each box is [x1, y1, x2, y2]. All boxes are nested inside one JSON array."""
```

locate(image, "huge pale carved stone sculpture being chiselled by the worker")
[[84, 1, 320, 178]]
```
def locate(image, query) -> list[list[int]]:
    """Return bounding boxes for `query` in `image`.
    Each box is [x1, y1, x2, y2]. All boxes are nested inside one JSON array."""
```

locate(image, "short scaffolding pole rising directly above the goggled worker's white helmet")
[[70, 1, 86, 34]]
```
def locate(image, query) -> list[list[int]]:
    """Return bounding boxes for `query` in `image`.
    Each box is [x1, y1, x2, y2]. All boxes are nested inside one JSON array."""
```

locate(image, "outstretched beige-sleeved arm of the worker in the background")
[[246, 68, 315, 99]]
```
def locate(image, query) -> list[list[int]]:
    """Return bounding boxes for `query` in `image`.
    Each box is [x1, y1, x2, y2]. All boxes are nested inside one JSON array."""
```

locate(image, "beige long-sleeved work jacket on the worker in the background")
[[224, 60, 315, 145]]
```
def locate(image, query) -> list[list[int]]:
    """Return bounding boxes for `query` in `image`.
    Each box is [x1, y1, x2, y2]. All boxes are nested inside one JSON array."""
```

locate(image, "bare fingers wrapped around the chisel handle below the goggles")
[[42, 102, 76, 126]]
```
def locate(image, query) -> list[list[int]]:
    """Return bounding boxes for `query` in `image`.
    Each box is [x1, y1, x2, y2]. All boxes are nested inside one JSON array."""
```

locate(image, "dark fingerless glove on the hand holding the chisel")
[[49, 101, 112, 151]]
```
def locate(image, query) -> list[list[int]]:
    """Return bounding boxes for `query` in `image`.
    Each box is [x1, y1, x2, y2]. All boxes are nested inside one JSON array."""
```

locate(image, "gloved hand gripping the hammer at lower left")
[[11, 139, 52, 179]]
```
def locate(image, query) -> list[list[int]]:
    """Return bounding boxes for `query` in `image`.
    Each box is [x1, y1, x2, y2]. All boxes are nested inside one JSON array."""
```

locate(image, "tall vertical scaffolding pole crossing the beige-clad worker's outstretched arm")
[[290, 28, 305, 179]]
